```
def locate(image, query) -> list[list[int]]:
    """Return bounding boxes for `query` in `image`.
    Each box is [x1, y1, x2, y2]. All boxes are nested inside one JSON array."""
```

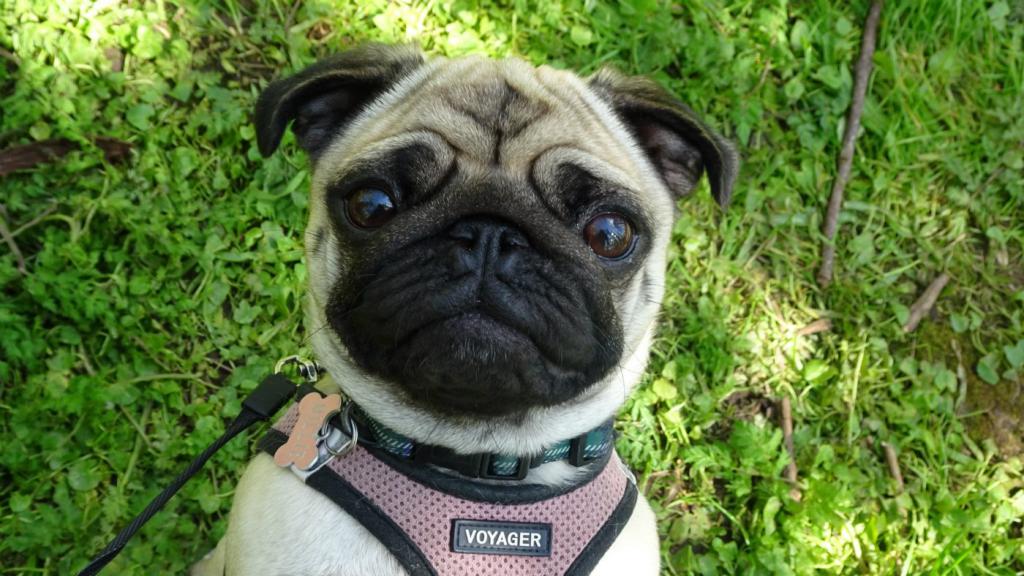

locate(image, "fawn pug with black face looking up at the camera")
[[193, 45, 738, 576]]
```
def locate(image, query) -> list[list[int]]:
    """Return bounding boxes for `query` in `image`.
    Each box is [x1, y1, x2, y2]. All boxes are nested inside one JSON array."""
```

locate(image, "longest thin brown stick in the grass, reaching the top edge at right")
[[818, 0, 882, 288]]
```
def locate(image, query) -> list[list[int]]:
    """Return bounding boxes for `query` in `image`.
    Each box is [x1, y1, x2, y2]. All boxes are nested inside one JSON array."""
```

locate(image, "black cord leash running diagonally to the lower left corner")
[[78, 372, 296, 576]]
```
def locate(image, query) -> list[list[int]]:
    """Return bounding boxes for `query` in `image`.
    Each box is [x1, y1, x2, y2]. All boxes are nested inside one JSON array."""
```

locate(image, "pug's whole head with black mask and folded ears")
[[256, 45, 737, 444]]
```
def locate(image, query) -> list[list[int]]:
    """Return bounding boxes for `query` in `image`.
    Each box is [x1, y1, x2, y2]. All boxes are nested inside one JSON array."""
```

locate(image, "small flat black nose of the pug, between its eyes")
[[447, 217, 529, 273]]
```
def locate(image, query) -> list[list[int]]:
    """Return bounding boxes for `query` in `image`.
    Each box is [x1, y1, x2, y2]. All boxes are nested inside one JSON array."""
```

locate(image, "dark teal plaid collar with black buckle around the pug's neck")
[[351, 405, 614, 480]]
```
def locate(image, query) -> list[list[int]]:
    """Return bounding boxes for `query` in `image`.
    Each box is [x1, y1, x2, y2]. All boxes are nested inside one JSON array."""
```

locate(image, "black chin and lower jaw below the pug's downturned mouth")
[[360, 312, 592, 417]]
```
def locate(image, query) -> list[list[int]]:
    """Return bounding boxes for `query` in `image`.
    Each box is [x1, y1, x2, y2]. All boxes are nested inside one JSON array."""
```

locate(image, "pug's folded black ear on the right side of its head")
[[588, 68, 739, 208]]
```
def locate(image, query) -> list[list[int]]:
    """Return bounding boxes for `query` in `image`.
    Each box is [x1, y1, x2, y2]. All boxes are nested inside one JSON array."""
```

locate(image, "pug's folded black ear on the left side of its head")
[[255, 44, 424, 158]]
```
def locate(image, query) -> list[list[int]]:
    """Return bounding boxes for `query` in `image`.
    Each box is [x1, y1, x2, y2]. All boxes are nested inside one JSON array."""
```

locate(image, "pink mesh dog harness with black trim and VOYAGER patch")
[[262, 405, 637, 576]]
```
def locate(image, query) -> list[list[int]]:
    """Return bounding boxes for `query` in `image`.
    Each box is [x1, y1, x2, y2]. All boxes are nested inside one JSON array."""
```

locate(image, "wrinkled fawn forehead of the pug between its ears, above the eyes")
[[317, 57, 656, 195]]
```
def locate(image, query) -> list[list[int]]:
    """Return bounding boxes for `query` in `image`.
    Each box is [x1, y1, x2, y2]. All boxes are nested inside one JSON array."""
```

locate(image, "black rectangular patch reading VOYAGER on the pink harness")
[[452, 520, 551, 556]]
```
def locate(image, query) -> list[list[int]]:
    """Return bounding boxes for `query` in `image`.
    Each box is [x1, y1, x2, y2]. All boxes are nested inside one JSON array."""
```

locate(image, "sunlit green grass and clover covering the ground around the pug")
[[0, 0, 1024, 574]]
